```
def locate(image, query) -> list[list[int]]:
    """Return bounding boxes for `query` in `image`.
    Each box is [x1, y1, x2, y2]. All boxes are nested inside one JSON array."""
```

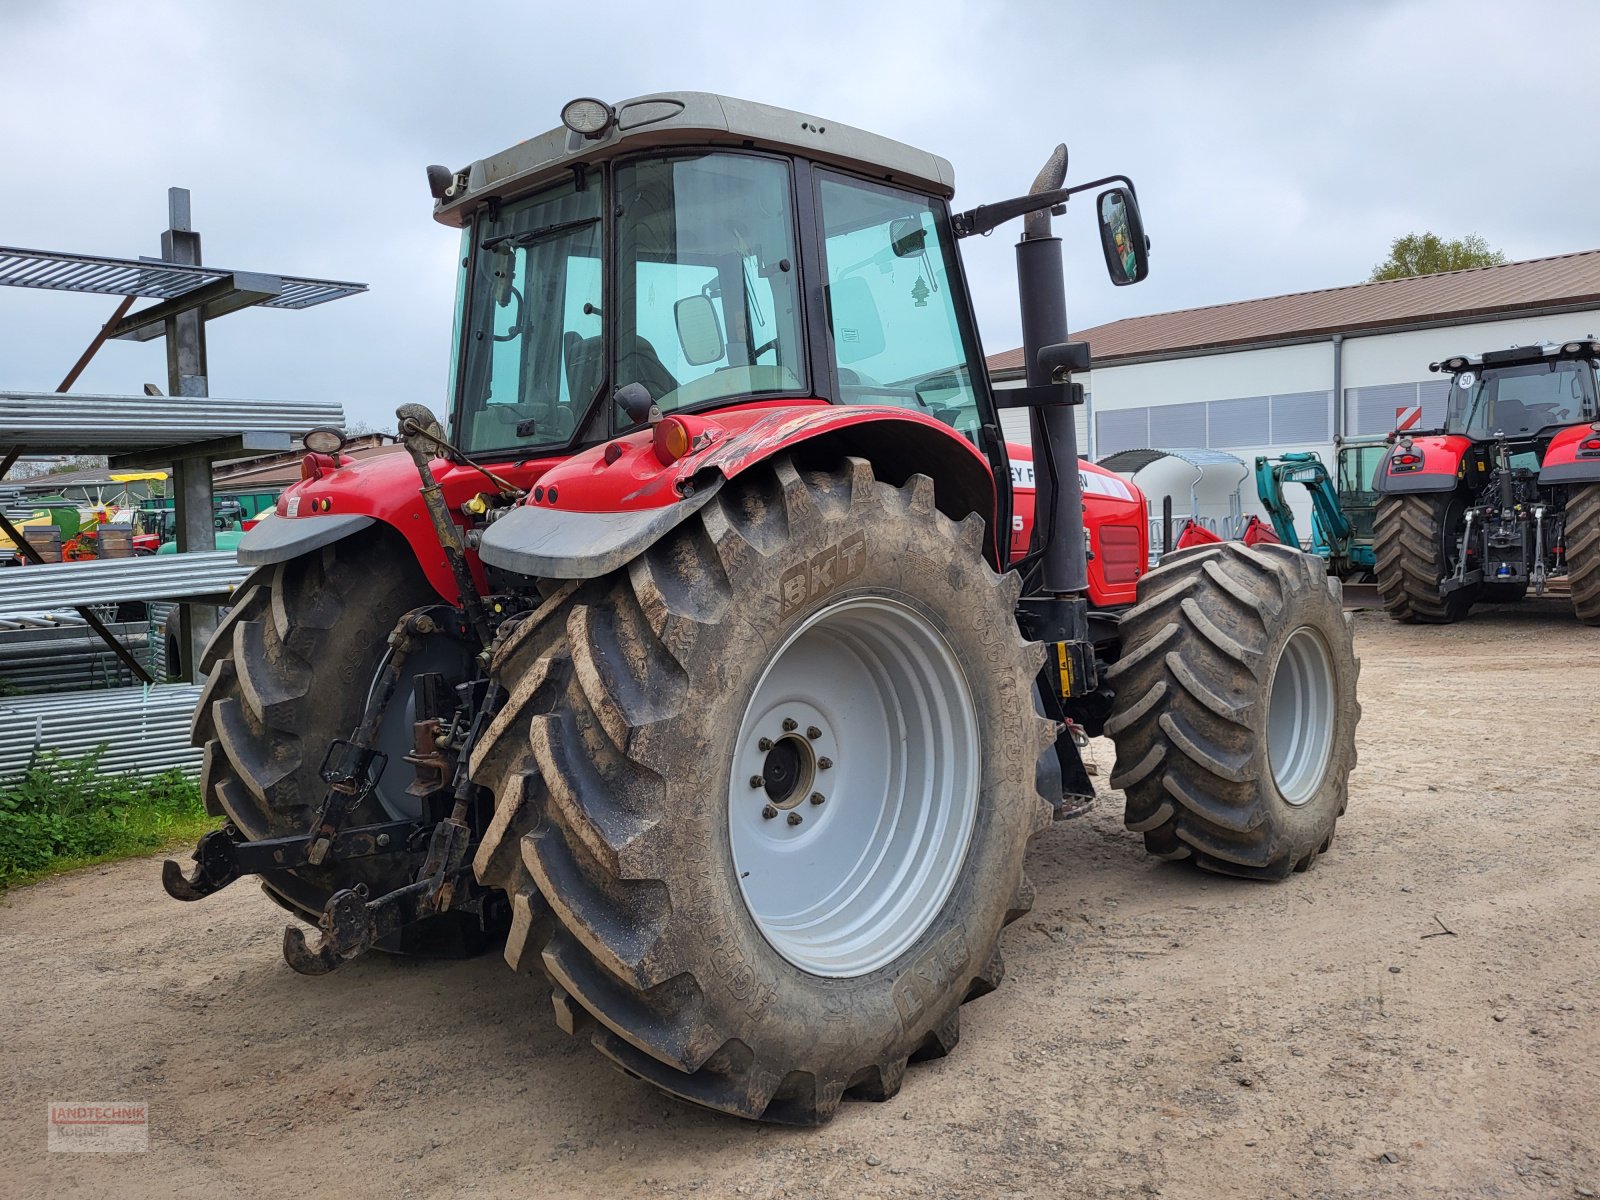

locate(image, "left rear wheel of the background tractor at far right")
[[1373, 491, 1474, 626]]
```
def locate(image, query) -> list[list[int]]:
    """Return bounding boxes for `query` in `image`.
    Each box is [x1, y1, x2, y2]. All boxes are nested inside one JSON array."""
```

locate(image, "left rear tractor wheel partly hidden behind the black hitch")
[[192, 534, 482, 954]]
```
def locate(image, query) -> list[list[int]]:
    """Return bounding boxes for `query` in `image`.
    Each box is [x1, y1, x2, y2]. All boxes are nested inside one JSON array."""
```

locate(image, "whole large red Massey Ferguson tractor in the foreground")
[[163, 93, 1358, 1123]]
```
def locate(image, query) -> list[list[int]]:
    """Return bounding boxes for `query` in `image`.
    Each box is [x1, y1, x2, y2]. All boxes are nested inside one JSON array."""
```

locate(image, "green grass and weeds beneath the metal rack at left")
[[0, 755, 218, 891]]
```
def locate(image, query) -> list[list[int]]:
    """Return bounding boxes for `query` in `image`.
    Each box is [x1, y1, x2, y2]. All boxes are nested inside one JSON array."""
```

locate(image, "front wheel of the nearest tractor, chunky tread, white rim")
[[1106, 542, 1362, 878]]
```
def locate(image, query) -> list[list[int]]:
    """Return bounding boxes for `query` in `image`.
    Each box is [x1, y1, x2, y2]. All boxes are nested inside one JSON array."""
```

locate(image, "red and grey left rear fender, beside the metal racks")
[[238, 453, 558, 603]]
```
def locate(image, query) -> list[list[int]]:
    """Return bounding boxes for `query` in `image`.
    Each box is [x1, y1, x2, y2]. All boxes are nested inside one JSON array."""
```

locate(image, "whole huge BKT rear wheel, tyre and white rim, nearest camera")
[[472, 458, 1053, 1125]]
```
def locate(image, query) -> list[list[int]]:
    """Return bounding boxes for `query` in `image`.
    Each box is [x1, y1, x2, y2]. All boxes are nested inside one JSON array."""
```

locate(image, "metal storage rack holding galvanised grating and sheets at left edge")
[[0, 187, 366, 776]]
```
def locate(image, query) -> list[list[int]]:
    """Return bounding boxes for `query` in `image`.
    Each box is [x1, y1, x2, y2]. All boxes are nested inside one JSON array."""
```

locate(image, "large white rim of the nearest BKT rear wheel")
[[728, 597, 979, 978]]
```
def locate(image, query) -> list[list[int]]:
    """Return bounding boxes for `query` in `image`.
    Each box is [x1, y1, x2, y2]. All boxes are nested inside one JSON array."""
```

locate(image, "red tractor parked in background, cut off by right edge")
[[1373, 338, 1600, 626]]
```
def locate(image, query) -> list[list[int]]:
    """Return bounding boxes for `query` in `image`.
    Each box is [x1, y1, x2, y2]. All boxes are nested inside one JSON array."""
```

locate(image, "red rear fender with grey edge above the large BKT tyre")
[[480, 400, 1000, 579]]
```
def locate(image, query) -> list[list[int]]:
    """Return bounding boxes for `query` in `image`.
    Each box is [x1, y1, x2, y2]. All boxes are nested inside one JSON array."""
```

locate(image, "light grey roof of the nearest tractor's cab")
[[434, 91, 955, 227]]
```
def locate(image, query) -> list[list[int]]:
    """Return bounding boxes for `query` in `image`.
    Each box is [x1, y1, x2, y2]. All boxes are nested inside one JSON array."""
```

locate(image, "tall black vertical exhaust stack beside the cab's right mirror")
[[1016, 146, 1090, 595]]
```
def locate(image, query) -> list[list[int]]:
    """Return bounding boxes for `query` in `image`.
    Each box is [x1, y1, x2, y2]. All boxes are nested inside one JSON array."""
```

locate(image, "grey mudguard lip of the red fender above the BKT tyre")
[[478, 475, 723, 579]]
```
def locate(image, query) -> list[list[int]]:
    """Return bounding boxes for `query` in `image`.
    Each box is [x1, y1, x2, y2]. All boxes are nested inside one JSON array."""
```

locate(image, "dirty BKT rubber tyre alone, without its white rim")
[[474, 459, 1053, 1125]]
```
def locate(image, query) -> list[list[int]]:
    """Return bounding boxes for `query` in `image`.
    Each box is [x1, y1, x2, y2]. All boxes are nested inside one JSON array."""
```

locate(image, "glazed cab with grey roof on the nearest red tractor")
[[435, 93, 1003, 474]]
